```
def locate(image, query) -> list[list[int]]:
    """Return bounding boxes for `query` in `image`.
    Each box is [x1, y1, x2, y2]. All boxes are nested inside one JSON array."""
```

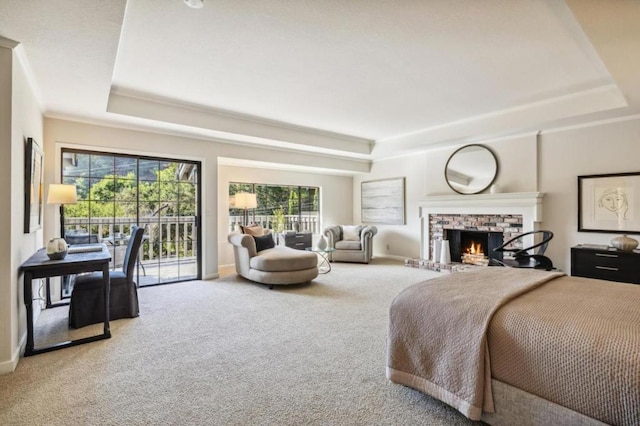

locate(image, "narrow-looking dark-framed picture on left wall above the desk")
[[24, 138, 44, 234]]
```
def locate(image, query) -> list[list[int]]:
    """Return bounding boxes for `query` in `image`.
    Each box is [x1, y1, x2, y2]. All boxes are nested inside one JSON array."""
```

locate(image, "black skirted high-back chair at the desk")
[[69, 226, 144, 328]]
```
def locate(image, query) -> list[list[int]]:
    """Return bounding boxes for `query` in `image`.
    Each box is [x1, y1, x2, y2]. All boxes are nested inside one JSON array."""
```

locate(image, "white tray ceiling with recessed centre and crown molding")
[[0, 0, 640, 165]]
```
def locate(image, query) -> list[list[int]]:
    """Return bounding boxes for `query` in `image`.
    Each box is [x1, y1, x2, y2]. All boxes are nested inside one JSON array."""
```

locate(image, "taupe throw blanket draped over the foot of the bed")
[[387, 267, 564, 420]]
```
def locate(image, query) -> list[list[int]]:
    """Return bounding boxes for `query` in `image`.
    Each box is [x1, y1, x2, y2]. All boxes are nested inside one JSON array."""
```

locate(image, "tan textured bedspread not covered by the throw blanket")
[[488, 277, 640, 426]]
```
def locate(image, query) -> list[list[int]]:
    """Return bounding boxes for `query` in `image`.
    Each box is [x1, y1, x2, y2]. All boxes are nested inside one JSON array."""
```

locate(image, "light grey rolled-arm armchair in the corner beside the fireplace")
[[324, 225, 378, 263]]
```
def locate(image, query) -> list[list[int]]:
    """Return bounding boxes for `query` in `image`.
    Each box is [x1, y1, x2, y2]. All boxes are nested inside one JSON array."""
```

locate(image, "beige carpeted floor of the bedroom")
[[0, 259, 480, 425]]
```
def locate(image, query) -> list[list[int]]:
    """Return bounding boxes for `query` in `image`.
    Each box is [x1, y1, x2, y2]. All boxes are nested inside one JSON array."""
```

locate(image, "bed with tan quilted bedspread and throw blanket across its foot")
[[386, 267, 640, 425]]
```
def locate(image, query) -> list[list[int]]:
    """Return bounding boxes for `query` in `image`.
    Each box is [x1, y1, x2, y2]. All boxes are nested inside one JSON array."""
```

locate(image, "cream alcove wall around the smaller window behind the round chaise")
[[218, 165, 353, 265]]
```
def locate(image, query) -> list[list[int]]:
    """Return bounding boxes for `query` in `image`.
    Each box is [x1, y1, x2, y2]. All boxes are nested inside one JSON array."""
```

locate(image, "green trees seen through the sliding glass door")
[[63, 153, 197, 266]]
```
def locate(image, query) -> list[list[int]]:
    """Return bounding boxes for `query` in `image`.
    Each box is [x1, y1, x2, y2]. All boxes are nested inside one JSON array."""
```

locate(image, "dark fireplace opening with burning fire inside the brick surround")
[[445, 229, 504, 265]]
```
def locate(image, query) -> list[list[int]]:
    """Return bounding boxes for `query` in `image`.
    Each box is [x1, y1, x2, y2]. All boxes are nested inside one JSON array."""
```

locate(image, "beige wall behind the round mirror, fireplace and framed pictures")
[[353, 117, 640, 272]]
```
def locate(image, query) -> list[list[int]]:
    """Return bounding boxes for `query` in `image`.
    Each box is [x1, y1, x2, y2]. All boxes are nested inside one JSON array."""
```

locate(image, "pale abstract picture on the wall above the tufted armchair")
[[361, 177, 405, 225]]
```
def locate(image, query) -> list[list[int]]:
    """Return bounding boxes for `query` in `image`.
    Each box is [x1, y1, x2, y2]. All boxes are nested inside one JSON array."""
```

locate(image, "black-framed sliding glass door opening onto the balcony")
[[62, 150, 201, 292]]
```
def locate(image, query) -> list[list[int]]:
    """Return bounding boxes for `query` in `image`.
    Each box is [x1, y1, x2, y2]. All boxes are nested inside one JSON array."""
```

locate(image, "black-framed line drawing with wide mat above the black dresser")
[[578, 172, 640, 234]]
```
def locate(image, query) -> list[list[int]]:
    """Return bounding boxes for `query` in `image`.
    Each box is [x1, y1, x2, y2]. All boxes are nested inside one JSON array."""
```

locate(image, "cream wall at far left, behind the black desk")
[[0, 46, 43, 374]]
